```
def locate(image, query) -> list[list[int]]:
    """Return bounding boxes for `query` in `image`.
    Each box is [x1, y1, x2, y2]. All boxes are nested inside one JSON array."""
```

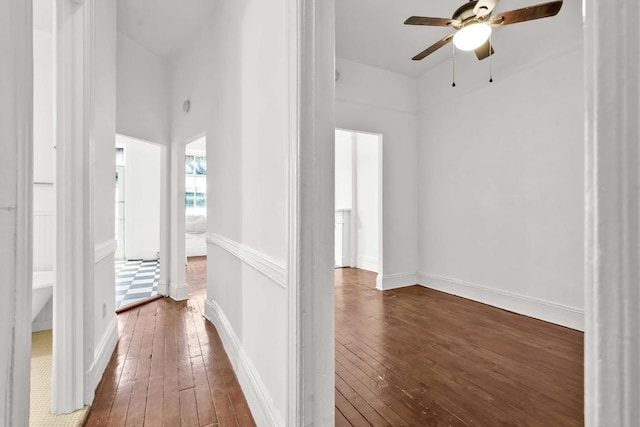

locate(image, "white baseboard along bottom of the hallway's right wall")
[[204, 299, 284, 427]]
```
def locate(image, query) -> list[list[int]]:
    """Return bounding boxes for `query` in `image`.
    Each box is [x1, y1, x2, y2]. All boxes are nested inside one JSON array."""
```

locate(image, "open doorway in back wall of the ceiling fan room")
[[335, 129, 383, 282]]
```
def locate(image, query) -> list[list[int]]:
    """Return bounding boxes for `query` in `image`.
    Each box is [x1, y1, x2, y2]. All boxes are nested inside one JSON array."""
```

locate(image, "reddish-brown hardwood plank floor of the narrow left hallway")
[[85, 257, 255, 427]]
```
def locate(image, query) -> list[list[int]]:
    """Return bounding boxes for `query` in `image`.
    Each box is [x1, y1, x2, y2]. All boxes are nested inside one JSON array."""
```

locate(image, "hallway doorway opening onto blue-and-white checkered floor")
[[115, 135, 162, 311]]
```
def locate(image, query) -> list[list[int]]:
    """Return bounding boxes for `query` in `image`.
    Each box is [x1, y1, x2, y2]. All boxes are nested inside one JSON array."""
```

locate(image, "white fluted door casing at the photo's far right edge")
[[583, 0, 640, 427]]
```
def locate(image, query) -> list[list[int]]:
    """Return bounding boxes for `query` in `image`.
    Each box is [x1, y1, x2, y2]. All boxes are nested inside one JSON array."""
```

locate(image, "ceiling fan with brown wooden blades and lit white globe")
[[404, 0, 562, 61]]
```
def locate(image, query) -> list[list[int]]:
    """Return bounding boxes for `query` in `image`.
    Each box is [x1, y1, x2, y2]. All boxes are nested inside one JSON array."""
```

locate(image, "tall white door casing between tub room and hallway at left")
[[51, 0, 95, 414]]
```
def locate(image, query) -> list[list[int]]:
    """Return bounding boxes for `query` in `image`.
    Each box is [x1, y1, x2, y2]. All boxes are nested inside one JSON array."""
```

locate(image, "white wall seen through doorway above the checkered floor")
[[116, 135, 161, 259]]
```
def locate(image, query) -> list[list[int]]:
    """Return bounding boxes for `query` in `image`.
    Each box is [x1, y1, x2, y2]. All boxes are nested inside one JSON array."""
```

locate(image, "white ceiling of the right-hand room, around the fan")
[[336, 0, 581, 76]]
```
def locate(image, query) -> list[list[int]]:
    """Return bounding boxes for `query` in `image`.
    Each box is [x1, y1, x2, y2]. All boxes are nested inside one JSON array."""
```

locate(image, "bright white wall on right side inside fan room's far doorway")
[[354, 133, 380, 272]]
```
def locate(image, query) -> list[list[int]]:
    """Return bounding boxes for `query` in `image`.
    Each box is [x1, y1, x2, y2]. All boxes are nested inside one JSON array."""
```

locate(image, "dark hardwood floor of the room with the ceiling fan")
[[335, 268, 583, 427]]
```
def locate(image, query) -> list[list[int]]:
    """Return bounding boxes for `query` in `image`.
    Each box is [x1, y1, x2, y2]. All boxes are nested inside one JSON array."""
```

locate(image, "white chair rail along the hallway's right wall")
[[207, 233, 287, 289]]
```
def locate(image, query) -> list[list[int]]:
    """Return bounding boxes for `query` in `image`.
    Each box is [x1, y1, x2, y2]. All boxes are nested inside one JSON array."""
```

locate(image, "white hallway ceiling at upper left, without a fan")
[[118, 0, 217, 61]]
